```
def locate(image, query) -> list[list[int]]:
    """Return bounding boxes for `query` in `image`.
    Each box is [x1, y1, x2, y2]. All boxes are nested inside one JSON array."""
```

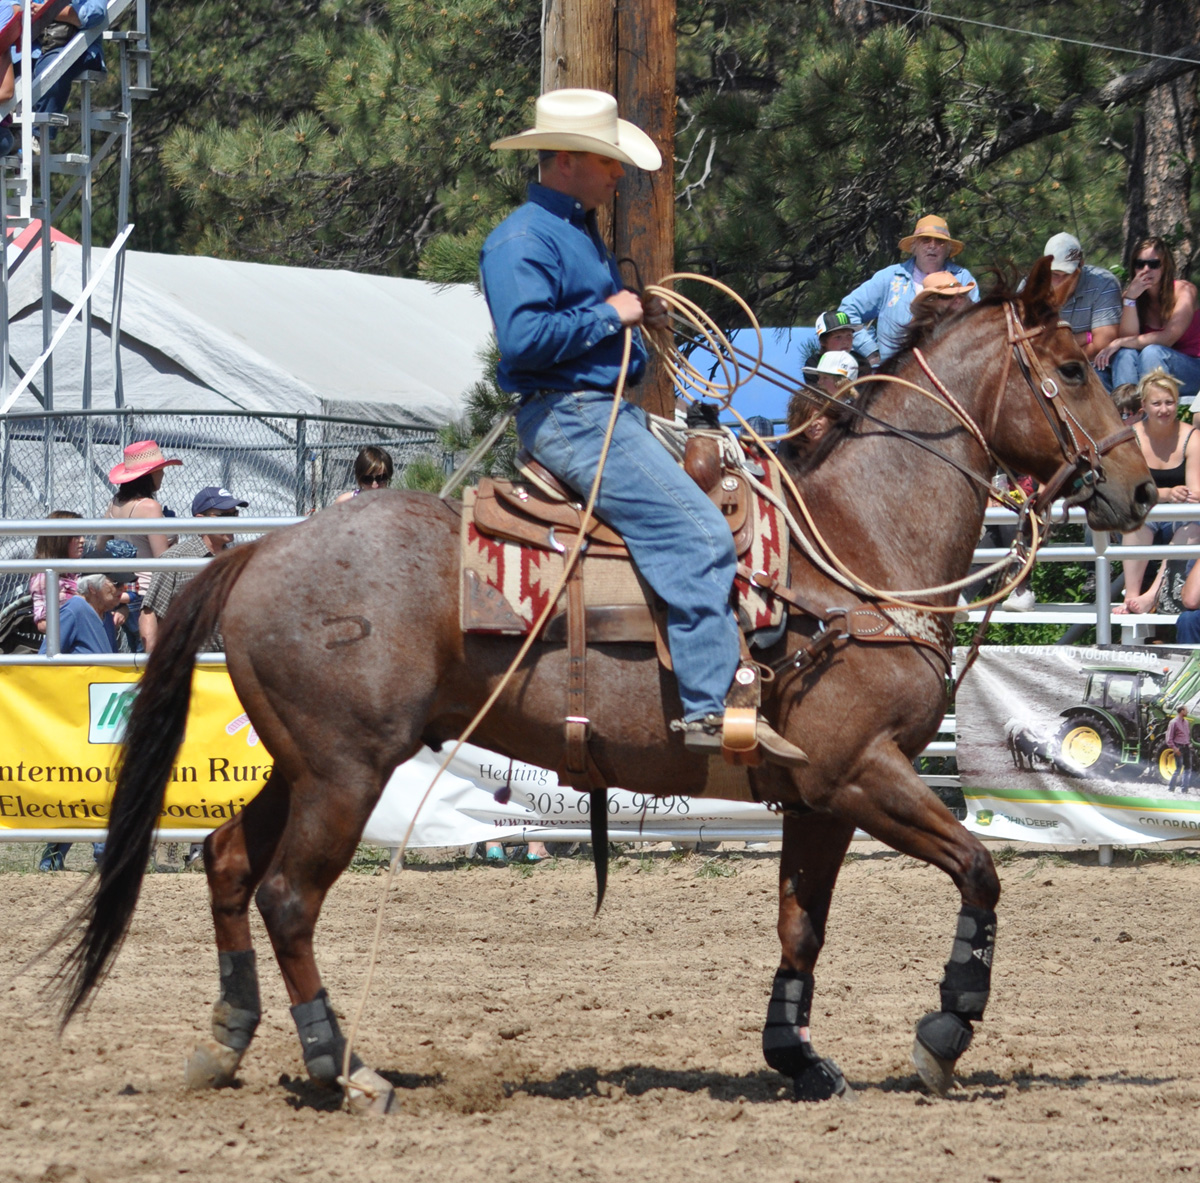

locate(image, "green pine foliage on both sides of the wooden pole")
[[96, 0, 1180, 299]]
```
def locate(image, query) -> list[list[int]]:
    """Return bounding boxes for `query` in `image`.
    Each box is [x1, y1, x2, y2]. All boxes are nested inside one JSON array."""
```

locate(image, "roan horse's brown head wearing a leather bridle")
[[985, 257, 1157, 530]]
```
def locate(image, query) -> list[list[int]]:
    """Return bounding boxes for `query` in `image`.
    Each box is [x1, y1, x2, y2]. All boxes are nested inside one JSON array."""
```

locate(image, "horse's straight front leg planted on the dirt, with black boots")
[[762, 813, 854, 1101]]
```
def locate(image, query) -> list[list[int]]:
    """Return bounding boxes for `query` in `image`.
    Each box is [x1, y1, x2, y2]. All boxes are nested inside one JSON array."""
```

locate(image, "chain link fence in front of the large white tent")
[[0, 409, 454, 602]]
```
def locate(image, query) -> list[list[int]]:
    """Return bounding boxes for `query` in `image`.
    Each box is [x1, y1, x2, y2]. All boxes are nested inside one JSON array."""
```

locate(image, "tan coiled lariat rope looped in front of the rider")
[[644, 272, 1043, 613]]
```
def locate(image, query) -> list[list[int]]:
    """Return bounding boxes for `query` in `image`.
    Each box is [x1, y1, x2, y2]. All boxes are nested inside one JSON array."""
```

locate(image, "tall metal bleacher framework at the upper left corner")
[[0, 0, 154, 414]]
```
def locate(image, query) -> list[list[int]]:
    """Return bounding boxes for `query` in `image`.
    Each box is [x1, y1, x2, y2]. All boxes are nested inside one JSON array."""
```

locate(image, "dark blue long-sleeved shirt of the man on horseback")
[[479, 185, 646, 396]]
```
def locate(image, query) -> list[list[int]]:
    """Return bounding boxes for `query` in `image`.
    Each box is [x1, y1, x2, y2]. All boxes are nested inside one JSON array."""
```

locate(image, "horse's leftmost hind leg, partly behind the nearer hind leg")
[[185, 769, 288, 1088]]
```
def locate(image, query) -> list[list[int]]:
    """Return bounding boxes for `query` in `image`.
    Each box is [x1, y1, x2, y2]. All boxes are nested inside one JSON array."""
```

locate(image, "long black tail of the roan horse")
[[54, 542, 257, 1027]]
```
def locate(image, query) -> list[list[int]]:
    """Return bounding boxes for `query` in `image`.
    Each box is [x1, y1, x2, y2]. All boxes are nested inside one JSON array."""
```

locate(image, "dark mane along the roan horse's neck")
[[779, 259, 1058, 475]]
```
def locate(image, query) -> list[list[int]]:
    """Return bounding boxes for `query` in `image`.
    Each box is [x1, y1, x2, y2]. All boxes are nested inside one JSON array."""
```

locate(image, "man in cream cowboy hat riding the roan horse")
[[480, 89, 806, 764]]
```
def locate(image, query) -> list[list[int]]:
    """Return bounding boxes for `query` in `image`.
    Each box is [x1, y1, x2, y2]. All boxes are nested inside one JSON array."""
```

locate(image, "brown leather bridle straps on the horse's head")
[[989, 302, 1136, 514]]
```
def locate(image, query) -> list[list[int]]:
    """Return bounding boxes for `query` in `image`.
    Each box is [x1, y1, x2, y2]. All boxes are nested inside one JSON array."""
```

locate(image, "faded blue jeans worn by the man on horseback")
[[516, 390, 738, 720]]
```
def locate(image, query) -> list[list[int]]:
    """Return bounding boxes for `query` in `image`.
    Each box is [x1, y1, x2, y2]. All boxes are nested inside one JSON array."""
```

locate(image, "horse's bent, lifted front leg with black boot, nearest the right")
[[832, 740, 1000, 1095]]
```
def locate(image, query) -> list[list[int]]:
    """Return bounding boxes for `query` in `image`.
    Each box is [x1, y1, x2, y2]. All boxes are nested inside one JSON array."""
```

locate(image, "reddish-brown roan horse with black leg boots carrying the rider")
[[60, 259, 1154, 1099]]
